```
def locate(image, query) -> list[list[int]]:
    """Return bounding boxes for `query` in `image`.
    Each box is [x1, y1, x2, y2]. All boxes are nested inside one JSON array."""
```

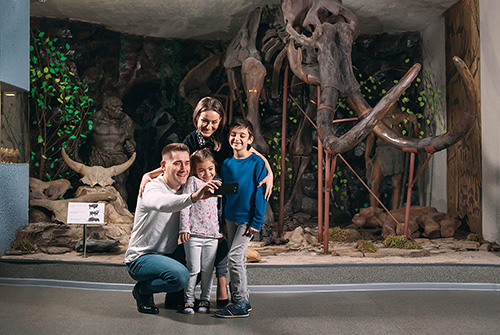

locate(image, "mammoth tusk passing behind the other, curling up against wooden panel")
[[347, 56, 478, 152]]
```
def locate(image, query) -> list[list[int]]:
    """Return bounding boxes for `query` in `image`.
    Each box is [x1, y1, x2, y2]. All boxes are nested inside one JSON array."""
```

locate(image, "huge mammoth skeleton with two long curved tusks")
[[181, 0, 477, 205]]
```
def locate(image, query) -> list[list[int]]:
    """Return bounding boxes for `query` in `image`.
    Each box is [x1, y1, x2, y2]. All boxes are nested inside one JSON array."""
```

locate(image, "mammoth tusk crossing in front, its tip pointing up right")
[[317, 64, 421, 153]]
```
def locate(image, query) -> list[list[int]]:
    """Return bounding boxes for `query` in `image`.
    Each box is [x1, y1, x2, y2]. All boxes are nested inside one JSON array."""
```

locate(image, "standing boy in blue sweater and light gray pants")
[[215, 118, 267, 318]]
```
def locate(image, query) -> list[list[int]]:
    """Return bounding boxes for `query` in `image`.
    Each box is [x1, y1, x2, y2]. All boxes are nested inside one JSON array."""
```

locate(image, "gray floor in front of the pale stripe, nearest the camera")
[[0, 285, 500, 335]]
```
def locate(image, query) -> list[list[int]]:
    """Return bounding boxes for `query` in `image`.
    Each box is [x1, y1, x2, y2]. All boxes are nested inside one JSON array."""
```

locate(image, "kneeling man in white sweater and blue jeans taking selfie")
[[125, 143, 220, 314]]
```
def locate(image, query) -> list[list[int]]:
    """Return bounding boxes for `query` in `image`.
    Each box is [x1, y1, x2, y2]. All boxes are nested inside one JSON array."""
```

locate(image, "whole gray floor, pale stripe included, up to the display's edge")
[[0, 260, 500, 335]]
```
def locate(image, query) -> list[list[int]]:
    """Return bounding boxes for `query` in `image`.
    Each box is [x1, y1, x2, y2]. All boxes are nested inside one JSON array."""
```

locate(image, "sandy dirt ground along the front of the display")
[[1, 239, 500, 265]]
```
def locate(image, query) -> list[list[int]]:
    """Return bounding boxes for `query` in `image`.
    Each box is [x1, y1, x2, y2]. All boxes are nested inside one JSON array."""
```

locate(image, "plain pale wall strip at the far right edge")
[[479, 0, 500, 243]]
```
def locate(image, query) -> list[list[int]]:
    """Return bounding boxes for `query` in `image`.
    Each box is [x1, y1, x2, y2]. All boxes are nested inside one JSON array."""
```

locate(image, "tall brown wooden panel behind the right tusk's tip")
[[445, 0, 482, 234]]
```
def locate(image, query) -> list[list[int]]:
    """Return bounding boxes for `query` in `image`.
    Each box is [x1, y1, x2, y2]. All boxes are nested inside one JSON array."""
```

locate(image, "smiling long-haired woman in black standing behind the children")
[[139, 97, 273, 308]]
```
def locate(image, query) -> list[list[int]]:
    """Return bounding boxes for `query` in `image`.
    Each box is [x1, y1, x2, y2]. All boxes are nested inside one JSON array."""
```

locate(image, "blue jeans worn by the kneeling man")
[[127, 254, 189, 294]]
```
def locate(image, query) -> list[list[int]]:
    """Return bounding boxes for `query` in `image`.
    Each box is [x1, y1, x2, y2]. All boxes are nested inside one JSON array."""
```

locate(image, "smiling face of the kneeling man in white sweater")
[[161, 151, 189, 190]]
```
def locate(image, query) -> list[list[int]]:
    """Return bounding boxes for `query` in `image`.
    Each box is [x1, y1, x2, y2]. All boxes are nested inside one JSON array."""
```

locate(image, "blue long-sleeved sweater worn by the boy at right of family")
[[221, 153, 267, 230]]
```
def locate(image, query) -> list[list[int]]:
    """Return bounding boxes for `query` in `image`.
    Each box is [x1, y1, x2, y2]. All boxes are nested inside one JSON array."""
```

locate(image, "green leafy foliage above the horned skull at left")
[[30, 32, 95, 180]]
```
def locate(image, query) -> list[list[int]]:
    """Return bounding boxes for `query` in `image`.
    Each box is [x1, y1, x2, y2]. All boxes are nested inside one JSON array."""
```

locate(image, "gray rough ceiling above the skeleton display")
[[30, 0, 458, 40]]
